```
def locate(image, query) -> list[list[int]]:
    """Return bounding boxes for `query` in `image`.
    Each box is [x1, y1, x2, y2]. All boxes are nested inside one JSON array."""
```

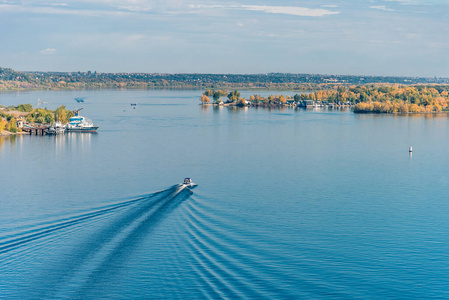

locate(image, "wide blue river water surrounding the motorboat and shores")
[[0, 90, 449, 299]]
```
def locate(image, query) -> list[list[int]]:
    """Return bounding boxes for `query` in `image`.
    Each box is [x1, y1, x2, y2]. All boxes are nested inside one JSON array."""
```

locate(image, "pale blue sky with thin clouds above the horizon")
[[0, 0, 449, 77]]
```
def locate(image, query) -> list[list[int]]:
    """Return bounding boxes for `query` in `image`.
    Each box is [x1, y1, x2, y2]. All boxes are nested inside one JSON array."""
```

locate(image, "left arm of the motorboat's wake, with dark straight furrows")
[[0, 184, 192, 298]]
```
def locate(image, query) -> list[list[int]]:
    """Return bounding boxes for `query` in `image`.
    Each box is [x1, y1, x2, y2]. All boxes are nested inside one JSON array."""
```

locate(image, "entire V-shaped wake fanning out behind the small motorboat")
[[0, 184, 326, 299]]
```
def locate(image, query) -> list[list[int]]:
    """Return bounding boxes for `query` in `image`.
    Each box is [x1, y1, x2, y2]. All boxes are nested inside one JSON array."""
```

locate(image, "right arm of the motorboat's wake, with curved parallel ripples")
[[177, 197, 295, 299]]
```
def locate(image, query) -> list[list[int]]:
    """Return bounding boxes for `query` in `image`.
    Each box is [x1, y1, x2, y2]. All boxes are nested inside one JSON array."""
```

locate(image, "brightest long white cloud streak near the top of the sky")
[[191, 5, 340, 17]]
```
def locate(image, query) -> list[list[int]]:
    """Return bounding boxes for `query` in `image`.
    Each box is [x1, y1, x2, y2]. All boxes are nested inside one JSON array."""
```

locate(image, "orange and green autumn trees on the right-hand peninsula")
[[200, 84, 449, 113]]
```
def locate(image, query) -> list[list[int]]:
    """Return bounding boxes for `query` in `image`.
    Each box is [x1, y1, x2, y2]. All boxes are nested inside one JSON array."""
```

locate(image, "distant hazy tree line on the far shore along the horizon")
[[0, 67, 449, 91]]
